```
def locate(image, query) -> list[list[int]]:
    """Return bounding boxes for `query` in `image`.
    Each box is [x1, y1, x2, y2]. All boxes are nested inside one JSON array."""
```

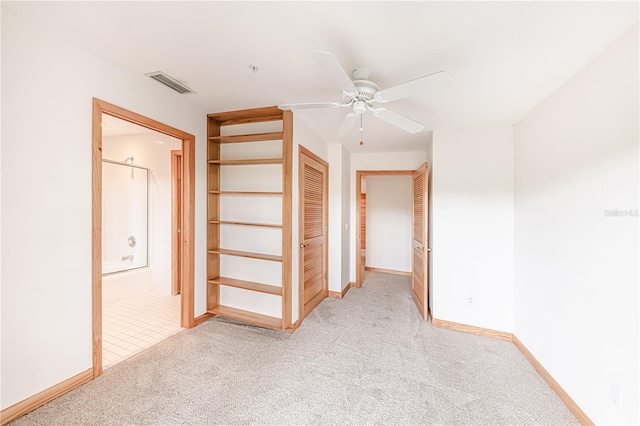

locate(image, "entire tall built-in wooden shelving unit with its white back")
[[207, 107, 293, 330]]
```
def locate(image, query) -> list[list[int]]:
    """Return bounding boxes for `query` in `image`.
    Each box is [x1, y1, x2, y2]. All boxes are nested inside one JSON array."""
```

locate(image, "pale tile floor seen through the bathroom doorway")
[[102, 292, 182, 369]]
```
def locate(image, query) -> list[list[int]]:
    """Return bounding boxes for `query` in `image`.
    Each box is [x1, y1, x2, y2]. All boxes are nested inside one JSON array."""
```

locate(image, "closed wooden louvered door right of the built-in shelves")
[[299, 147, 329, 320]]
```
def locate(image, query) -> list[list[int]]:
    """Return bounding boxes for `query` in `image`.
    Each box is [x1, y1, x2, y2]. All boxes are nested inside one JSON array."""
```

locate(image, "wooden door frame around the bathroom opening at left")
[[91, 98, 195, 378]]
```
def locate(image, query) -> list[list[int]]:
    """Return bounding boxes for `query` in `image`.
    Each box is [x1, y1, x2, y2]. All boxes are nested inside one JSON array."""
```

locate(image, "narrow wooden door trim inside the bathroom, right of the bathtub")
[[171, 149, 183, 296]]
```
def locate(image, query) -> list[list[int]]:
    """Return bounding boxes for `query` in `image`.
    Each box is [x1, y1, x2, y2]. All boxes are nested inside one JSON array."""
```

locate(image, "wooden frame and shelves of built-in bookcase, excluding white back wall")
[[207, 106, 293, 330]]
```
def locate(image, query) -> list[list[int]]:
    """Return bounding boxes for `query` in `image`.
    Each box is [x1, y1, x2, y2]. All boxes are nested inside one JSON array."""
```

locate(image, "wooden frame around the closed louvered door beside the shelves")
[[297, 145, 329, 325]]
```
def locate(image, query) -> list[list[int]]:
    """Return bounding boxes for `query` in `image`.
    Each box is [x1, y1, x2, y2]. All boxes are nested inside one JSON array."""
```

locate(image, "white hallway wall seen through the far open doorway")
[[365, 175, 413, 272]]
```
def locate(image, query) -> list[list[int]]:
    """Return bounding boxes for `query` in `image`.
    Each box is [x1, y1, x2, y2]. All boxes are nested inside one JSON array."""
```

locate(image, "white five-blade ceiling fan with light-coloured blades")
[[278, 51, 453, 136]]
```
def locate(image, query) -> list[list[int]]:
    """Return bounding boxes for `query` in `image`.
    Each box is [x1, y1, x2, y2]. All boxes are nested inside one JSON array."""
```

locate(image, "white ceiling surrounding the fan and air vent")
[[2, 1, 639, 152]]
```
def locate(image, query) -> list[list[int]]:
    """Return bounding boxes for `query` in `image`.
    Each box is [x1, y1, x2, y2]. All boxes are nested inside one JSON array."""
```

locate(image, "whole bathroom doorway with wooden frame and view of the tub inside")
[[93, 99, 194, 377]]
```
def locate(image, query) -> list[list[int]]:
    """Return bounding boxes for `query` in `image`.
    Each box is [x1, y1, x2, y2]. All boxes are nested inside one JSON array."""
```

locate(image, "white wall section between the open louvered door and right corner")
[[431, 126, 513, 332]]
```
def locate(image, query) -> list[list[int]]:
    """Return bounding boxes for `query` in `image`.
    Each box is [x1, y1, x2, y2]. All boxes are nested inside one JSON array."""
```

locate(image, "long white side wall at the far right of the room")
[[515, 26, 640, 424]]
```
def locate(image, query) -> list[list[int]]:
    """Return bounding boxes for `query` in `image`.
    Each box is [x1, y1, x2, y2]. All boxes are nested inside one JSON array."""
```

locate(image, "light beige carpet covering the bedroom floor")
[[13, 272, 578, 426]]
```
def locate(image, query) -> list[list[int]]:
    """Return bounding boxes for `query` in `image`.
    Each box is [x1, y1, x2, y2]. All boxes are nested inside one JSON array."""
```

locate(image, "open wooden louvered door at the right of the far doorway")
[[411, 163, 431, 320]]
